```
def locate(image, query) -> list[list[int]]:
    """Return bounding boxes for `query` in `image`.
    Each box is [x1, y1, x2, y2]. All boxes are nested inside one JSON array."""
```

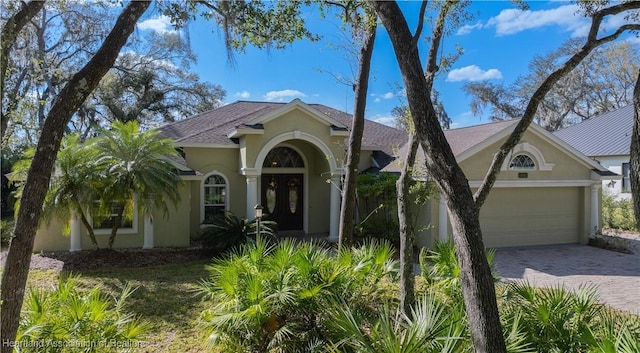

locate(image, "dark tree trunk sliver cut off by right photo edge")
[[629, 72, 640, 228]]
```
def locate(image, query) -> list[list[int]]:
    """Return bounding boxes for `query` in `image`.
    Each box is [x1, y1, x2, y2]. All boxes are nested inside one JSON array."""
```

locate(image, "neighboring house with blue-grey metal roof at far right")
[[554, 105, 634, 198]]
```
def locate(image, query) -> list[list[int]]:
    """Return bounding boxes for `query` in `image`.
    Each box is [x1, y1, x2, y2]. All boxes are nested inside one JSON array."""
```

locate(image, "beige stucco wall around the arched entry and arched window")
[[183, 110, 348, 238]]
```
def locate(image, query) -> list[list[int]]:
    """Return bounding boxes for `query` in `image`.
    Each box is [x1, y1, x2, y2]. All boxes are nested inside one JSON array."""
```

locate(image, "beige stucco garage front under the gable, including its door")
[[418, 132, 601, 247]]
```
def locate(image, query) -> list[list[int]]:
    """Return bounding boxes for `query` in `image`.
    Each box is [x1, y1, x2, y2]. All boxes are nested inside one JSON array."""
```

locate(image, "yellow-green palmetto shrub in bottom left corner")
[[16, 277, 149, 352]]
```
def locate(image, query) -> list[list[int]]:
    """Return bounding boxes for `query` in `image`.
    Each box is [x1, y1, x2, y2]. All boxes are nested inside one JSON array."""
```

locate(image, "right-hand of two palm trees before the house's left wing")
[[93, 121, 182, 248]]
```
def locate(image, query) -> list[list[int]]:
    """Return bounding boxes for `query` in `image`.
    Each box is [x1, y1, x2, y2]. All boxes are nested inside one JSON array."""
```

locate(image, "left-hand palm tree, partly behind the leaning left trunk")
[[13, 134, 98, 248]]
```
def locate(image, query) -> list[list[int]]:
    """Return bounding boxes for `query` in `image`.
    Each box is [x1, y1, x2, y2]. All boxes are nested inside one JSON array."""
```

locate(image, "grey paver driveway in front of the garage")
[[495, 244, 640, 314]]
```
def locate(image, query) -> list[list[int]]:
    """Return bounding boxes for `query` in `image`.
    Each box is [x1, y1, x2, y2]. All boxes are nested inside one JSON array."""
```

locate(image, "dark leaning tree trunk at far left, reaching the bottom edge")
[[0, 1, 150, 353]]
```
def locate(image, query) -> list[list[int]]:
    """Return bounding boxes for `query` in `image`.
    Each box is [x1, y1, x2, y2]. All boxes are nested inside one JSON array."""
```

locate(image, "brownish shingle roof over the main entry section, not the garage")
[[159, 101, 407, 153]]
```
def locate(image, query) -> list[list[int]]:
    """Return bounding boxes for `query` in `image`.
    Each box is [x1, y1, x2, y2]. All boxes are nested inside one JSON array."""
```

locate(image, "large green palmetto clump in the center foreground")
[[200, 240, 397, 352]]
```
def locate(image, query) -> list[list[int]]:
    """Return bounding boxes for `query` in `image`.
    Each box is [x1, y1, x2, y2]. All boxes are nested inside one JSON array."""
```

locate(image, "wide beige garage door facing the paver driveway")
[[480, 187, 581, 247]]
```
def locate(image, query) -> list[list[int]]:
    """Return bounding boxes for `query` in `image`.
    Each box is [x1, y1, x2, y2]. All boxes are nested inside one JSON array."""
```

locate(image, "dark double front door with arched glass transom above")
[[261, 146, 305, 230]]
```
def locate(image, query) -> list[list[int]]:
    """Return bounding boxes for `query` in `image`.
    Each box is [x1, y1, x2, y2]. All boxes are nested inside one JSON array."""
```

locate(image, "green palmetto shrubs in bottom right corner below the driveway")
[[501, 282, 640, 353]]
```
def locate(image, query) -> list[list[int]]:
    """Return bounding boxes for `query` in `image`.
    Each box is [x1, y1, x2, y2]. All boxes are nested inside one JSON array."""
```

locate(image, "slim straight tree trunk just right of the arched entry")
[[338, 25, 377, 246]]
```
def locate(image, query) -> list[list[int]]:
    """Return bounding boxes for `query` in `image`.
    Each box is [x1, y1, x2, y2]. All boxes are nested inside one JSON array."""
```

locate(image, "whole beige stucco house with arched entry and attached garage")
[[35, 99, 607, 251]]
